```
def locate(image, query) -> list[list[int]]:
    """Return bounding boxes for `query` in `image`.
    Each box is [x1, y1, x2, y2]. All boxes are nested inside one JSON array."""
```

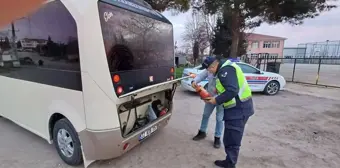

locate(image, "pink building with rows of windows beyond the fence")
[[246, 33, 286, 58]]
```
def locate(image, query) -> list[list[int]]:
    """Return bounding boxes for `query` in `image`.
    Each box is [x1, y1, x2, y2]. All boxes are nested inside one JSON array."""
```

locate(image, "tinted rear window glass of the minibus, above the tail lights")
[[99, 2, 174, 72]]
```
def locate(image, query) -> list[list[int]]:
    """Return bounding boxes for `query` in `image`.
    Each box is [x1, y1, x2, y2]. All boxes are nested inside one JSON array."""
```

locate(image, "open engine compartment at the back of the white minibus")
[[118, 89, 174, 137]]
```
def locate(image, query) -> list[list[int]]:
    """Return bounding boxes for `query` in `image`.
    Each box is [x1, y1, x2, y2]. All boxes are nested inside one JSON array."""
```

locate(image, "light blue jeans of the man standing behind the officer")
[[200, 103, 224, 137]]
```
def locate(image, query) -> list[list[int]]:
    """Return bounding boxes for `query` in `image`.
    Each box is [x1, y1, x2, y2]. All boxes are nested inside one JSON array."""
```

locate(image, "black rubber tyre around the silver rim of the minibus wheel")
[[53, 118, 83, 166]]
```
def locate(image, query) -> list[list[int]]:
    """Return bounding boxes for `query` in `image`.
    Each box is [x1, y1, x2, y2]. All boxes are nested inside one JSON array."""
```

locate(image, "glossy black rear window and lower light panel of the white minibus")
[[98, 2, 174, 96]]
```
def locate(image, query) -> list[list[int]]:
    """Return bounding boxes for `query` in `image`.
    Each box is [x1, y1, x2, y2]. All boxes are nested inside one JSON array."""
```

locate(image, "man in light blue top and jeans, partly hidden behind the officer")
[[191, 56, 224, 148]]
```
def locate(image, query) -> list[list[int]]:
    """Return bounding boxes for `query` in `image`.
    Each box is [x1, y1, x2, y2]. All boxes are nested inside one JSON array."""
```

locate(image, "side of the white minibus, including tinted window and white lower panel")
[[0, 1, 86, 139]]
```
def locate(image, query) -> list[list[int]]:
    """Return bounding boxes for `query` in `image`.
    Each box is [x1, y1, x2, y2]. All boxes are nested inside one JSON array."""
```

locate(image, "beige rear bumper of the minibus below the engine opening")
[[79, 112, 172, 160]]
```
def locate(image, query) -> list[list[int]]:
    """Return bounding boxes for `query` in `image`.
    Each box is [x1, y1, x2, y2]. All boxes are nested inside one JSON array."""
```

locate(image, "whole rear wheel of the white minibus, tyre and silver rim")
[[53, 118, 83, 166]]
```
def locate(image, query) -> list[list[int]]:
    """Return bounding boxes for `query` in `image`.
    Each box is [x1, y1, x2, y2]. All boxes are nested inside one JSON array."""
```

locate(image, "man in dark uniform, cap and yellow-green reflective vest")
[[205, 59, 254, 168]]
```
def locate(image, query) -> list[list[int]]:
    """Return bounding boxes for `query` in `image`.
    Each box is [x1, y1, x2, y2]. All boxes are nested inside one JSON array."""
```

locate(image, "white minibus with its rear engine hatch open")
[[0, 0, 181, 167]]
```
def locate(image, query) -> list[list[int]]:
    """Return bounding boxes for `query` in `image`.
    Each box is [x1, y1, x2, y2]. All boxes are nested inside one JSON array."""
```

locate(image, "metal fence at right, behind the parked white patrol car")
[[249, 57, 340, 88]]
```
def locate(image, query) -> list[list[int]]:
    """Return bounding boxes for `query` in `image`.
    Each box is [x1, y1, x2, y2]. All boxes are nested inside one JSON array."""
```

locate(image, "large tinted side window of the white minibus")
[[0, 1, 81, 90]]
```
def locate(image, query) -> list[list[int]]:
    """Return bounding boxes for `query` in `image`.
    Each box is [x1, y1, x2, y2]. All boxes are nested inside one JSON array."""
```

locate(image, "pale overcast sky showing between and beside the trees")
[[163, 2, 340, 47]]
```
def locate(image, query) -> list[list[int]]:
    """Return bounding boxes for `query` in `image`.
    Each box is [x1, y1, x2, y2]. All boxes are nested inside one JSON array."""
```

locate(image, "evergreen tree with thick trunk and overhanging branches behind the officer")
[[204, 0, 337, 57]]
